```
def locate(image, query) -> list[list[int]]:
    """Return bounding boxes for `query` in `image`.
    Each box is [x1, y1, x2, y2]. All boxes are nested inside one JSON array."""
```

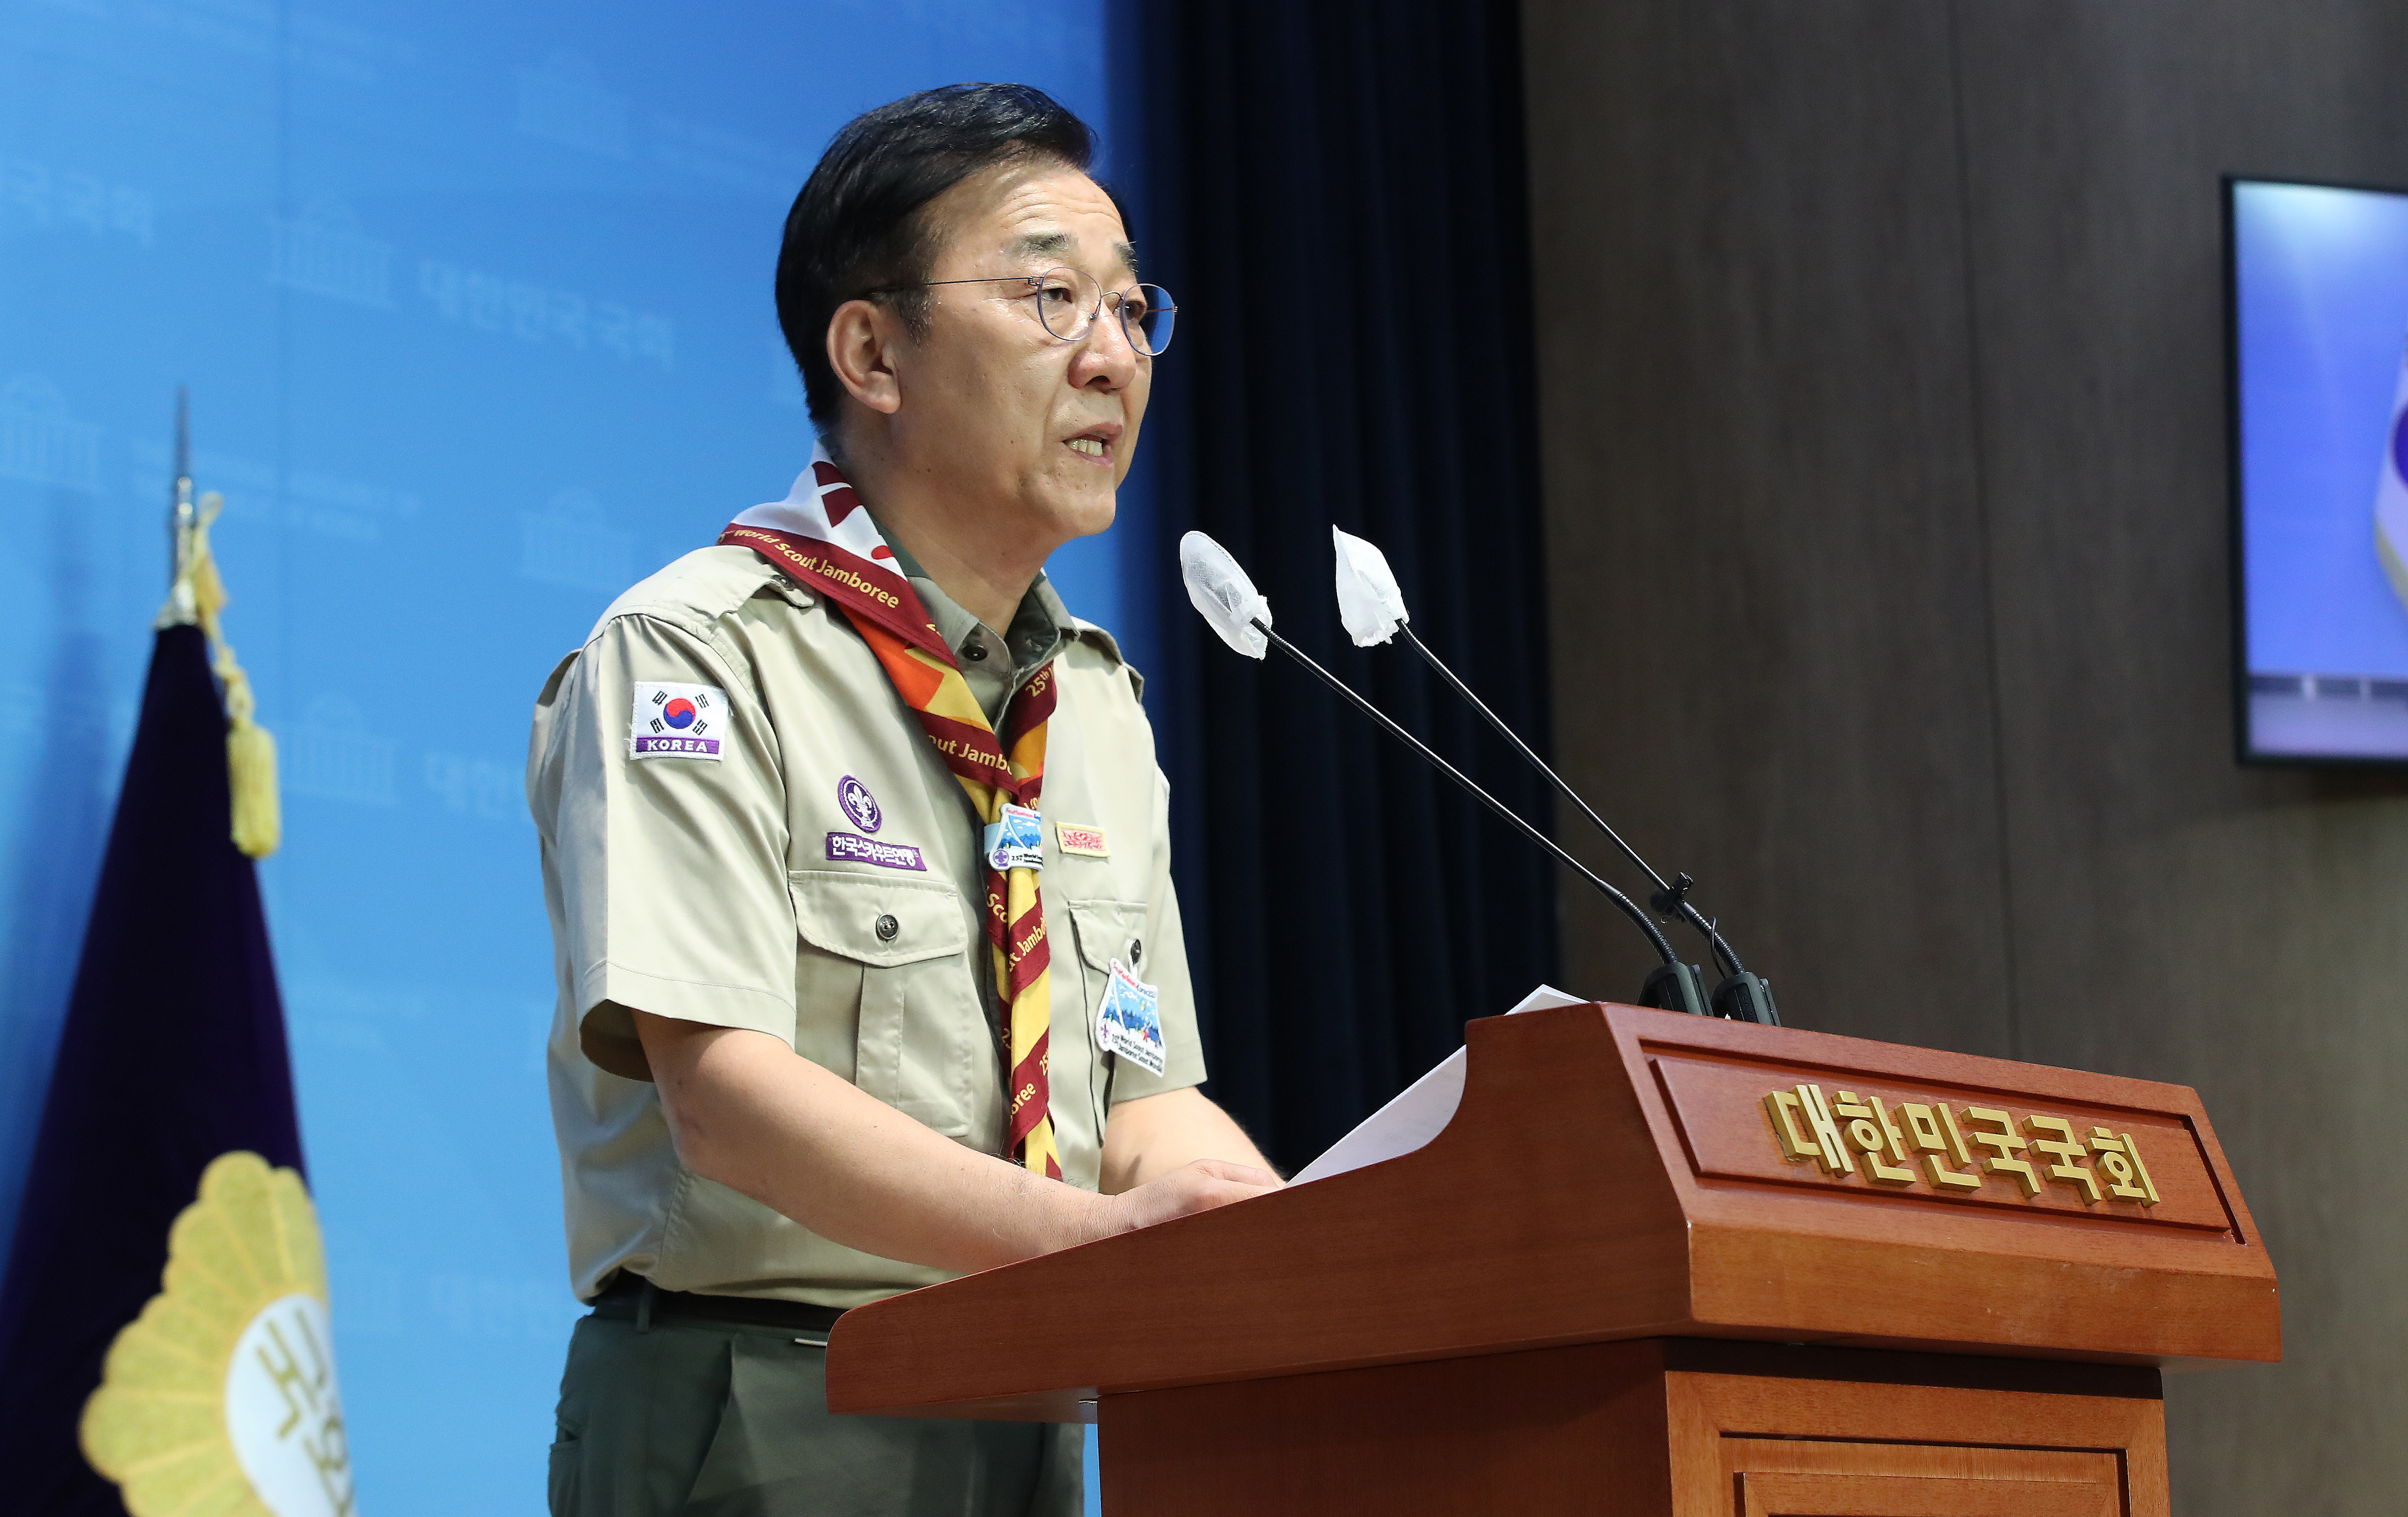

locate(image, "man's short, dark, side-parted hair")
[[778, 84, 1096, 431]]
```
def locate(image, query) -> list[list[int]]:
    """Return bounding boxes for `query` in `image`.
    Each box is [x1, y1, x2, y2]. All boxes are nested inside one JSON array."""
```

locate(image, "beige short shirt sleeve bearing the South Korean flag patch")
[[530, 614, 795, 1079]]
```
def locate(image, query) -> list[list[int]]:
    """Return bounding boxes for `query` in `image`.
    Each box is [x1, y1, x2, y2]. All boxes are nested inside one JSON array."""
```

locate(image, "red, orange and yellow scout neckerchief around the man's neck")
[[720, 448, 1062, 1180]]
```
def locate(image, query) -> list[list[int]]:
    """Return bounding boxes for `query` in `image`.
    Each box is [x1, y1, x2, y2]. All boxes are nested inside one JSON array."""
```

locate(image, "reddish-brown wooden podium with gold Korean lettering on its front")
[[828, 1004, 2280, 1517]]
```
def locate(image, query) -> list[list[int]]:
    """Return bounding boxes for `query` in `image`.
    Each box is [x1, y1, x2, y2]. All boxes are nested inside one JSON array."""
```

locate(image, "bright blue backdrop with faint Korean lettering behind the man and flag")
[[0, 0, 1156, 1517]]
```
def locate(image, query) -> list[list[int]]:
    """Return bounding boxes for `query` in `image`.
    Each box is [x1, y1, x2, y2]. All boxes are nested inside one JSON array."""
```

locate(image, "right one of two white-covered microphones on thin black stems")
[[1329, 527, 1782, 1028]]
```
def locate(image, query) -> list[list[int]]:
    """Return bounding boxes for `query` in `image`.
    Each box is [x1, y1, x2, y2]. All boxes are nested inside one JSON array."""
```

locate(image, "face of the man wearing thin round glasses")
[[893, 164, 1153, 542]]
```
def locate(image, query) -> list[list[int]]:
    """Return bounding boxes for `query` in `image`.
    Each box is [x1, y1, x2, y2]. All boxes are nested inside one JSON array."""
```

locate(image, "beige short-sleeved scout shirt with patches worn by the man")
[[527, 535, 1204, 1308]]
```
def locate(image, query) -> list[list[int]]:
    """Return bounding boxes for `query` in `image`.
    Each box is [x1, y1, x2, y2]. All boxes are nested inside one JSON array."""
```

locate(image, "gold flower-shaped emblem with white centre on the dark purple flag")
[[84, 1151, 354, 1517]]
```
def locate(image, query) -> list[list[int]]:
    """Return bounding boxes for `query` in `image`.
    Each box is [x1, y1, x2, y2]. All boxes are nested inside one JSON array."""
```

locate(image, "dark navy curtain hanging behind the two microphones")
[[1115, 0, 1556, 1168]]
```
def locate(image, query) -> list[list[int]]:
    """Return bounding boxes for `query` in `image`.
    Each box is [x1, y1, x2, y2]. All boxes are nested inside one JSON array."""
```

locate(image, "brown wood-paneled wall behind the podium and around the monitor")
[[1524, 0, 2408, 1515]]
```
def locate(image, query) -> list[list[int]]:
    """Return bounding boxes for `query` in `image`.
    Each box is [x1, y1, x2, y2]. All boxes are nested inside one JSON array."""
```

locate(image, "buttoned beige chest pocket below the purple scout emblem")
[[787, 872, 992, 1139]]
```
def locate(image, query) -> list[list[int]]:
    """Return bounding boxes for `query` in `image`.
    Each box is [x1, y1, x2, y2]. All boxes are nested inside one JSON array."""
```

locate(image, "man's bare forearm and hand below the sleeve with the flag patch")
[[633, 1011, 1279, 1271]]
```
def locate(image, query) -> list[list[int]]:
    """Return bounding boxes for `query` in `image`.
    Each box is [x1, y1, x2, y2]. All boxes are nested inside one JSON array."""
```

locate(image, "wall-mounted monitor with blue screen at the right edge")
[[2225, 178, 2408, 763]]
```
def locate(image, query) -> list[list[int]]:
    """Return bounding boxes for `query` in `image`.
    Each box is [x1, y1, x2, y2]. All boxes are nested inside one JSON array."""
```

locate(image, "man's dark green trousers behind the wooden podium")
[[551, 1317, 1086, 1517]]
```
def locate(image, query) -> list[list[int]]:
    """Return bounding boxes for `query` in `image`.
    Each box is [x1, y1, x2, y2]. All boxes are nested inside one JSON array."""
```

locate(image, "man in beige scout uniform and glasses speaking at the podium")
[[527, 87, 1279, 1517]]
